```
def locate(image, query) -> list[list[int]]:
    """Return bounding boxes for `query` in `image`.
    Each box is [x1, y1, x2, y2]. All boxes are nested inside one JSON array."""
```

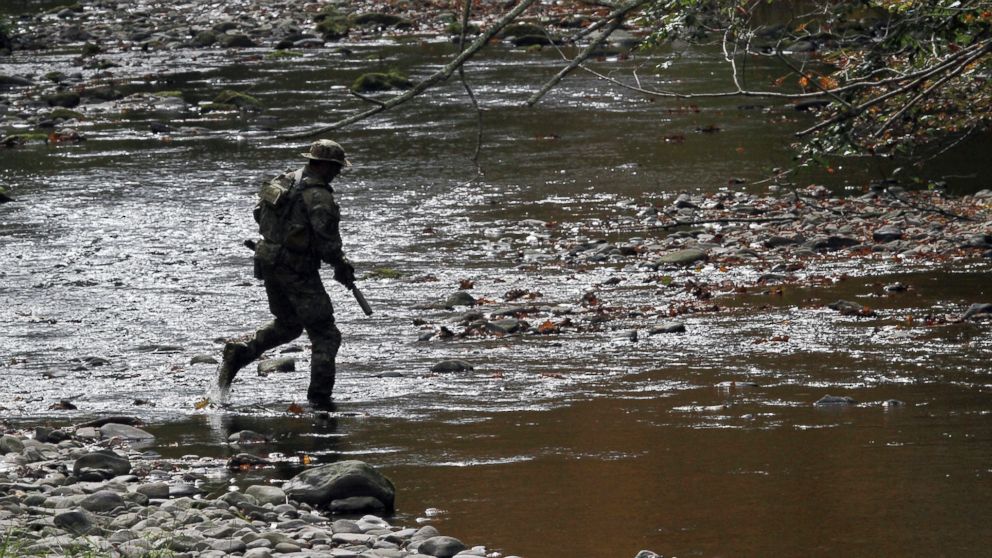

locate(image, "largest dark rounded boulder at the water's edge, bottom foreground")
[[283, 460, 396, 512]]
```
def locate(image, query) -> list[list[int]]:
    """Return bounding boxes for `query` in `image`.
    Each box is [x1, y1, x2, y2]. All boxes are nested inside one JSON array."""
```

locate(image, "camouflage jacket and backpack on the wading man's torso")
[[255, 167, 345, 272]]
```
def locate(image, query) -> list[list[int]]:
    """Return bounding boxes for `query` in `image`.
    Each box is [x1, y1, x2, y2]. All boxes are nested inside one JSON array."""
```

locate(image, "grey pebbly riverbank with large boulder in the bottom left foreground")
[[0, 421, 552, 558]]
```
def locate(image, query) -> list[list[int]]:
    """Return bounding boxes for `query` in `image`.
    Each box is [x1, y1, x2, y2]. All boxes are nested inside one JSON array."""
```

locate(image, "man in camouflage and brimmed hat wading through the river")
[[217, 140, 355, 406]]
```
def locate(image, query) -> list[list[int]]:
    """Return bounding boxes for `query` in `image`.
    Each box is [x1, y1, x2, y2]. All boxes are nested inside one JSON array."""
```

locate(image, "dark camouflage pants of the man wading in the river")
[[249, 268, 341, 398]]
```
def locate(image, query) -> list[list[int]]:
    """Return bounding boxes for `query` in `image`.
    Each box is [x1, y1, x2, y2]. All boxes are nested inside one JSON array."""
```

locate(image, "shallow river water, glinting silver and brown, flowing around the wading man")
[[0, 37, 992, 558]]
